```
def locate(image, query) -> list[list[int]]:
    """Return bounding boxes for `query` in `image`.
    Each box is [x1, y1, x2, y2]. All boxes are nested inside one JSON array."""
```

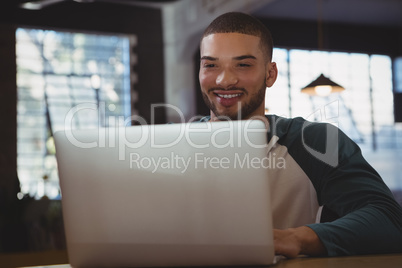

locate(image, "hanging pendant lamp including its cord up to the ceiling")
[[301, 0, 345, 96]]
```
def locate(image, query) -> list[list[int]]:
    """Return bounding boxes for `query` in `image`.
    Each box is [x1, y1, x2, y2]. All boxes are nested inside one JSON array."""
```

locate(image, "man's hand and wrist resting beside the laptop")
[[274, 226, 327, 258]]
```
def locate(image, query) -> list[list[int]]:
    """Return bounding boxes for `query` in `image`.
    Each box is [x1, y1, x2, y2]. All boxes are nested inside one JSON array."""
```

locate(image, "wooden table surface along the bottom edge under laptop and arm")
[[18, 254, 402, 268]]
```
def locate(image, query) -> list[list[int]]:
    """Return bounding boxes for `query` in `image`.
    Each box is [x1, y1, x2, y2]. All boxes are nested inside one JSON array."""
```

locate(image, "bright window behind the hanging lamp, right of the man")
[[266, 48, 402, 151]]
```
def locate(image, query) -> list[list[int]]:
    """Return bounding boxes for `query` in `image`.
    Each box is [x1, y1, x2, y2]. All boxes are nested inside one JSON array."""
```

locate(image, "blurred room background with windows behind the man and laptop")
[[0, 0, 402, 266]]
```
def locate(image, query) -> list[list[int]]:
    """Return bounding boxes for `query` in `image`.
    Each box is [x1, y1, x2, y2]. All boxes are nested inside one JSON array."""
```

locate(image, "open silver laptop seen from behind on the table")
[[54, 120, 275, 267]]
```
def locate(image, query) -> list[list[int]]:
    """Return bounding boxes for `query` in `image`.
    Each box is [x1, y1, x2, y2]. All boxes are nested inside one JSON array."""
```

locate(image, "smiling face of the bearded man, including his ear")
[[199, 33, 277, 120]]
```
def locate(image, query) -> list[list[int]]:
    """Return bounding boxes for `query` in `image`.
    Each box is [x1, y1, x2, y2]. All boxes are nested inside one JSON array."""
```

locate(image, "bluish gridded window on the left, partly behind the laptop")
[[16, 28, 131, 199]]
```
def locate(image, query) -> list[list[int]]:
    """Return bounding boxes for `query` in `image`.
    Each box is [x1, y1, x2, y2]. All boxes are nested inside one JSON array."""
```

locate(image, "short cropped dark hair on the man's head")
[[202, 12, 274, 61]]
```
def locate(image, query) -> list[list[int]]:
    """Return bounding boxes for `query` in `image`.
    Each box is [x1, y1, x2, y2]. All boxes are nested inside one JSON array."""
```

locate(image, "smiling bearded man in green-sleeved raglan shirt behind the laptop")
[[199, 12, 402, 257]]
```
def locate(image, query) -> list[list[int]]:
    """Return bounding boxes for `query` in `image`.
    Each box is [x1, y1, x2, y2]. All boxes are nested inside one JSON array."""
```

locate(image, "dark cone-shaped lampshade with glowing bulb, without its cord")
[[301, 74, 345, 96]]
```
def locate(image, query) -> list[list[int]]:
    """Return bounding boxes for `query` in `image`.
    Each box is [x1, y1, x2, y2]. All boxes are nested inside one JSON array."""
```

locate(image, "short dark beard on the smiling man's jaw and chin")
[[202, 79, 266, 120]]
